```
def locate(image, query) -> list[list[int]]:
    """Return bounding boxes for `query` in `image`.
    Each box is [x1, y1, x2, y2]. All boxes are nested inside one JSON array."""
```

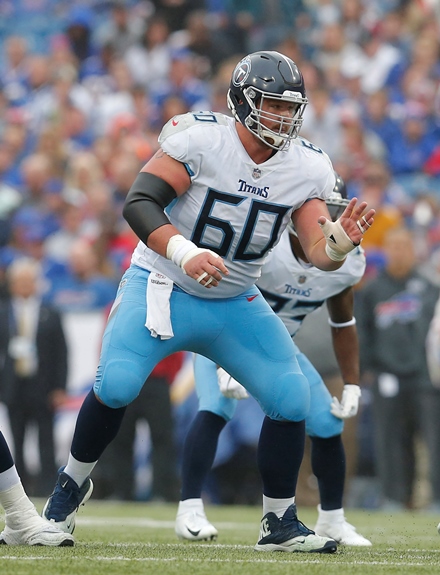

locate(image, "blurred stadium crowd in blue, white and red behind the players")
[[0, 0, 440, 510]]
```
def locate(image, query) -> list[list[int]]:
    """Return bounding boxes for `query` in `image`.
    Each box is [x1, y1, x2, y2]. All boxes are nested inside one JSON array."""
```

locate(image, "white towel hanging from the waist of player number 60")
[[145, 272, 174, 339]]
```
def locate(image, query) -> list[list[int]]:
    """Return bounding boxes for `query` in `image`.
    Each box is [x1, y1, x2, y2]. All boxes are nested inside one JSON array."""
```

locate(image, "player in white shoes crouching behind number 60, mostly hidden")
[[175, 176, 371, 546]]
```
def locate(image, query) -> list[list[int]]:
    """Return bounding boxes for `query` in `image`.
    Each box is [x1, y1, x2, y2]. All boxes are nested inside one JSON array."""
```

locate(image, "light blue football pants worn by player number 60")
[[94, 266, 310, 421]]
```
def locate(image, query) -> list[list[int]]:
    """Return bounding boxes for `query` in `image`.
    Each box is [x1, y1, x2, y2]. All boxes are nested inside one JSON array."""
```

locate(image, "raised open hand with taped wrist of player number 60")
[[318, 198, 376, 261]]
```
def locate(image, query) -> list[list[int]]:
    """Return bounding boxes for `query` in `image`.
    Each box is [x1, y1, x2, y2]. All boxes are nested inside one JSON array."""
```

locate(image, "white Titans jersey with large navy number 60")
[[132, 112, 335, 298]]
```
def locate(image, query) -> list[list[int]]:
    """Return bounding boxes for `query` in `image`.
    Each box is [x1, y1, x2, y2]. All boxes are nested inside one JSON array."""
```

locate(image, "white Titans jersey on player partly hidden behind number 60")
[[257, 232, 366, 337]]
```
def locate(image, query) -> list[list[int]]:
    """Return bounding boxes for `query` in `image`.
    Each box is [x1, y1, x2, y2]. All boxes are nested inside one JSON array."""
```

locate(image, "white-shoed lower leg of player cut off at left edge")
[[0, 431, 74, 547]]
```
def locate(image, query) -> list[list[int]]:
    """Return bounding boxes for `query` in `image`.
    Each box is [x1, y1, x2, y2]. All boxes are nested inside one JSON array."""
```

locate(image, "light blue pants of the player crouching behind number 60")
[[194, 343, 344, 438]]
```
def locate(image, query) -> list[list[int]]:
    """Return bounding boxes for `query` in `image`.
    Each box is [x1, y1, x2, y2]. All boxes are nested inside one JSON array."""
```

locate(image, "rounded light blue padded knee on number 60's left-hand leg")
[[93, 359, 146, 409]]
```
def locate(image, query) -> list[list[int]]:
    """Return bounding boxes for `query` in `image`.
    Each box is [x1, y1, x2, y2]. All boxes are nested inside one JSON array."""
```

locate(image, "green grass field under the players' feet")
[[0, 501, 440, 575]]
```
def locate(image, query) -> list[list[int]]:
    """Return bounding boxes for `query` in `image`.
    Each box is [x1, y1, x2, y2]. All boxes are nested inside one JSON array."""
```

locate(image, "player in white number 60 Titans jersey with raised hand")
[[43, 51, 374, 553]]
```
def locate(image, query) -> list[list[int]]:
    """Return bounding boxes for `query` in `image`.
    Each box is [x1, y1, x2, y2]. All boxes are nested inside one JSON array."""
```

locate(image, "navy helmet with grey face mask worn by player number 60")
[[227, 51, 308, 150]]
